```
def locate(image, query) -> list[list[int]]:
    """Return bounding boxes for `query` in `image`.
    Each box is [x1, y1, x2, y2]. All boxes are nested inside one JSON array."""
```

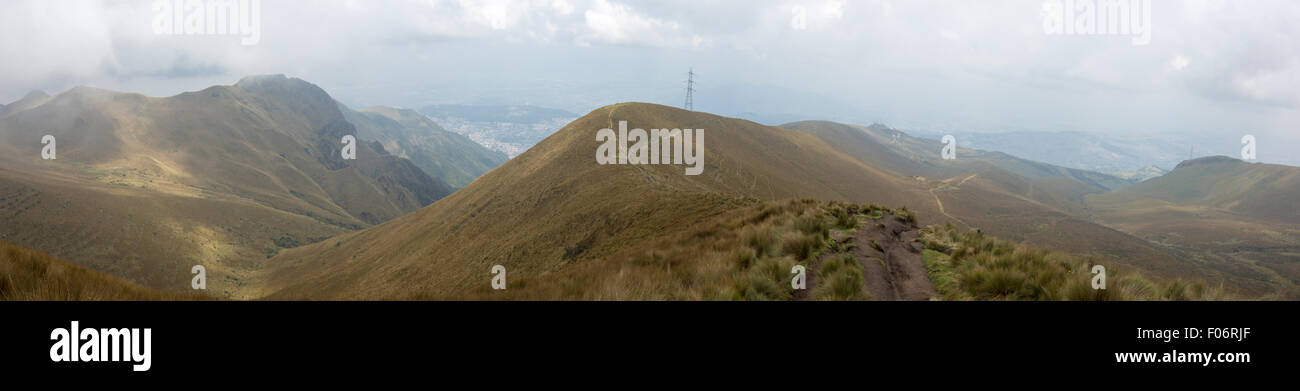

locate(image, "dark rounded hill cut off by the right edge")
[[1088, 156, 1300, 297]]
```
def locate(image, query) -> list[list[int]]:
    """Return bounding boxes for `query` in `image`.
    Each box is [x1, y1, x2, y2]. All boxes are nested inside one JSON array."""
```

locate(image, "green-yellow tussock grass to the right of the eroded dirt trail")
[[922, 225, 1229, 301]]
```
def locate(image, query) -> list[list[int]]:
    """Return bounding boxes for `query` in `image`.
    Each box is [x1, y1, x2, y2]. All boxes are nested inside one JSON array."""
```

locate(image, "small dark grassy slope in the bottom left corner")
[[0, 242, 207, 301]]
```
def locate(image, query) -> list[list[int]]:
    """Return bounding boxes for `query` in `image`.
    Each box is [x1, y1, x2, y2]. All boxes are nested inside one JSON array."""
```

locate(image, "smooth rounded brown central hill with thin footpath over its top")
[[269, 104, 924, 299]]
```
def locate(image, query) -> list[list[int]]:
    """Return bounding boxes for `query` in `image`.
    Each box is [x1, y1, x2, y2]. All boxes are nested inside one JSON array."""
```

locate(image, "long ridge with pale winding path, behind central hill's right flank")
[[784, 121, 1232, 288]]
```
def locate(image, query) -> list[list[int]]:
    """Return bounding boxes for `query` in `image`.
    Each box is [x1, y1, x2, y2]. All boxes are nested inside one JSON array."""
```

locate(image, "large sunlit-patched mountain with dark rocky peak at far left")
[[0, 75, 451, 297]]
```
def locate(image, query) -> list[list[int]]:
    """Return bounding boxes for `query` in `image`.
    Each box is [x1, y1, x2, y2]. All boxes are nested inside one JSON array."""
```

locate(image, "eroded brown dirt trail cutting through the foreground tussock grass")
[[850, 214, 939, 300]]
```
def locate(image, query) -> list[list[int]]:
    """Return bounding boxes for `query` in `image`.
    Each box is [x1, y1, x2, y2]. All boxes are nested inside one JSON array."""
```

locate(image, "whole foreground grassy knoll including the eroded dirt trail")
[[454, 199, 1232, 301]]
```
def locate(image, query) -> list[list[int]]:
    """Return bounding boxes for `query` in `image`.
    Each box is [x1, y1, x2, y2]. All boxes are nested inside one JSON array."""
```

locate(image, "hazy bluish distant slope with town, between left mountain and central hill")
[[420, 104, 579, 157]]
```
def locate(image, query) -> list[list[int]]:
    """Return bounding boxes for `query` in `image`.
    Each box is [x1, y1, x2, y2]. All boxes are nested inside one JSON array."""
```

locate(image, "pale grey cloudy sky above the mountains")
[[0, 0, 1300, 164]]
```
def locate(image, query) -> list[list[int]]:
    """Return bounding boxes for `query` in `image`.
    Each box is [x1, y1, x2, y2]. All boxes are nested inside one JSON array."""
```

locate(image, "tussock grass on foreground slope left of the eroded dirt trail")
[[464, 199, 880, 300]]
